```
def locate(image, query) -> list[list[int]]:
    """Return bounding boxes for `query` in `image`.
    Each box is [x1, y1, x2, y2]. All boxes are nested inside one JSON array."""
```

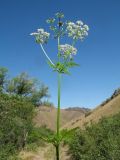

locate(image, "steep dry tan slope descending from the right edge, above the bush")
[[63, 94, 120, 129]]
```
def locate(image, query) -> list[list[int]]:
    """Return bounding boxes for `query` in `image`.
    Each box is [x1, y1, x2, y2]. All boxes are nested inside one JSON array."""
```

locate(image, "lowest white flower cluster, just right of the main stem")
[[59, 44, 77, 58]]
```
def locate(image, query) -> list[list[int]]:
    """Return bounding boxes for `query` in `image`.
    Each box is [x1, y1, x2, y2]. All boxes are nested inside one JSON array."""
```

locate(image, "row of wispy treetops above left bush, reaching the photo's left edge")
[[0, 67, 50, 106]]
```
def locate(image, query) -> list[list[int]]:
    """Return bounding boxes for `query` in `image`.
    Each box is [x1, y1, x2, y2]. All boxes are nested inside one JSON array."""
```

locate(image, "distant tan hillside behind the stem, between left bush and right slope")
[[34, 106, 88, 130]]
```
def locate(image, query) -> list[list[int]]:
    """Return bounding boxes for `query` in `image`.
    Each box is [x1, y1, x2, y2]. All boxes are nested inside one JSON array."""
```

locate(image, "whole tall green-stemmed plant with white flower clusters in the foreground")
[[30, 13, 89, 160]]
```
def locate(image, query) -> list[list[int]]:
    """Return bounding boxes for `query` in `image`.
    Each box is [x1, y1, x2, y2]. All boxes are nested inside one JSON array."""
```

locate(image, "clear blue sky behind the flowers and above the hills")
[[0, 0, 120, 108]]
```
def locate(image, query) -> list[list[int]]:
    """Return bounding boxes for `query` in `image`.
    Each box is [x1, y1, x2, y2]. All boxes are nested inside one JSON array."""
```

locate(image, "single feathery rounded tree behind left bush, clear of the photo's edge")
[[6, 72, 49, 105]]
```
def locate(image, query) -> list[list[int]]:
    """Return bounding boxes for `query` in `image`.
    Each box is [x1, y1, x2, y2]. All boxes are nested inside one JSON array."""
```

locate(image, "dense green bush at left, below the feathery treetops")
[[0, 94, 35, 160]]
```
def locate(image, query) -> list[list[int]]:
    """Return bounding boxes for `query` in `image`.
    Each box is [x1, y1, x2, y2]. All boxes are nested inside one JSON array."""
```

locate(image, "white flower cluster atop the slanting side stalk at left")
[[30, 28, 50, 44]]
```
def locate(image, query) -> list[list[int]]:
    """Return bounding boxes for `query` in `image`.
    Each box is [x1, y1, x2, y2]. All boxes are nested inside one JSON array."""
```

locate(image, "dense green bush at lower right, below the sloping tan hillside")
[[69, 113, 120, 160]]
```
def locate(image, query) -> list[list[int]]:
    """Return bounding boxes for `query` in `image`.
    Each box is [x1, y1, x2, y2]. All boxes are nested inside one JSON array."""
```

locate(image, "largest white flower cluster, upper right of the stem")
[[66, 21, 89, 40]]
